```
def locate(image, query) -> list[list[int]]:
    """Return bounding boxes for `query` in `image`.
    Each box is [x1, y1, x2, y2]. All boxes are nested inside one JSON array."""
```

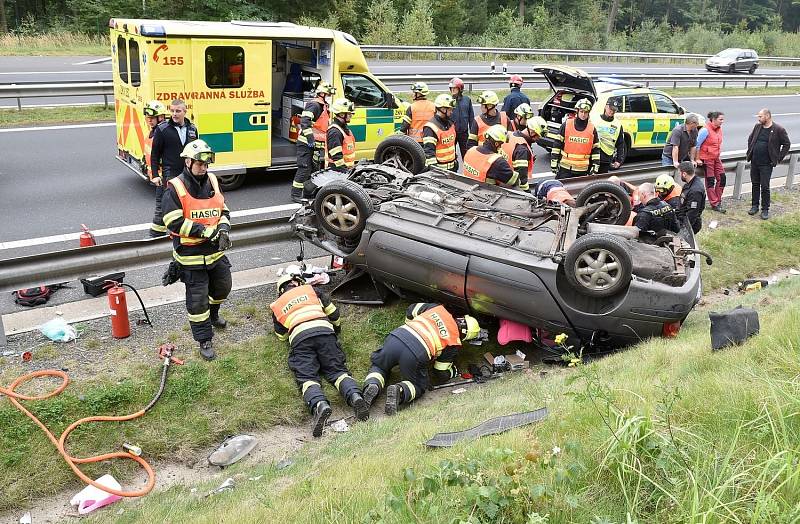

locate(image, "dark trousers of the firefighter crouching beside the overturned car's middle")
[[364, 333, 431, 403]]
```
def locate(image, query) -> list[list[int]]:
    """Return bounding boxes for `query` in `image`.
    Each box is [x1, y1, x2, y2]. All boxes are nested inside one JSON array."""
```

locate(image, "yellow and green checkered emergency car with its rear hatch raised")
[[534, 66, 703, 158]]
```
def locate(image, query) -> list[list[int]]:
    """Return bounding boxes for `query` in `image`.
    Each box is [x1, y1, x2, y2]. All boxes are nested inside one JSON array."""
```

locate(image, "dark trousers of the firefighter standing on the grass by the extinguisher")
[[181, 257, 233, 342]]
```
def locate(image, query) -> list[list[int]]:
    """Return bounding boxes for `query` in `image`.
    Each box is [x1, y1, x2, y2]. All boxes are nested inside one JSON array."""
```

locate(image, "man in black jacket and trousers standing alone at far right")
[[747, 108, 792, 220]]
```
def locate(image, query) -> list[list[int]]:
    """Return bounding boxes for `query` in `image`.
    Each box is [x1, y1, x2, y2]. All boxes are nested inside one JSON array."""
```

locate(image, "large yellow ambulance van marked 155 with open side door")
[[109, 18, 406, 190]]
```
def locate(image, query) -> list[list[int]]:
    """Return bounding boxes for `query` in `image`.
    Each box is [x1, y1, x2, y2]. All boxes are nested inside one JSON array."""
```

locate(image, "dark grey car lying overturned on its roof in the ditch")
[[292, 164, 711, 347]]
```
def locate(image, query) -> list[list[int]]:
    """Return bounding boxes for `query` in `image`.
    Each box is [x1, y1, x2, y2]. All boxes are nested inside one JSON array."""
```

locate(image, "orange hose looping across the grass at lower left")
[[0, 344, 183, 497]]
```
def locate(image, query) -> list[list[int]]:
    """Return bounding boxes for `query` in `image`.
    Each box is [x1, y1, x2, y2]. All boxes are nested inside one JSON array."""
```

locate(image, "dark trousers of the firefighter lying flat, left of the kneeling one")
[[289, 333, 361, 413]]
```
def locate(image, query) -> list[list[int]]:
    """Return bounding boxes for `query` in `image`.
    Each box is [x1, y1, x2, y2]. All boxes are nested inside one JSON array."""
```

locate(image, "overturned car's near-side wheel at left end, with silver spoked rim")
[[314, 180, 375, 238]]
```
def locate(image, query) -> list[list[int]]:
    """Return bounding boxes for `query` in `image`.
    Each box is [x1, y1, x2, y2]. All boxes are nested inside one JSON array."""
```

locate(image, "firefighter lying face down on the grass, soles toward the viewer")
[[269, 274, 369, 437]]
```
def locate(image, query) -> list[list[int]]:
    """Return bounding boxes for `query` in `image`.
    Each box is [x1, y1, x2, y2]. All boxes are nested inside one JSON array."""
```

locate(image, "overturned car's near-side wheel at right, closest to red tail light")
[[564, 233, 633, 298]]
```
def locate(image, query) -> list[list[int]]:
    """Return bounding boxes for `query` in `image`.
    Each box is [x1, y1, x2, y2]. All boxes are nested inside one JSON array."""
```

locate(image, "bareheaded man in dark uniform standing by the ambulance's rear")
[[149, 98, 198, 236]]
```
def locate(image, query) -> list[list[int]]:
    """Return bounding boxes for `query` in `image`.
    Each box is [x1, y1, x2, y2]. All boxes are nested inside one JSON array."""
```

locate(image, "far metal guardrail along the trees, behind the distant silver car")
[[361, 45, 800, 64]]
